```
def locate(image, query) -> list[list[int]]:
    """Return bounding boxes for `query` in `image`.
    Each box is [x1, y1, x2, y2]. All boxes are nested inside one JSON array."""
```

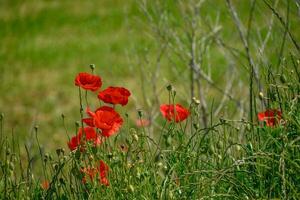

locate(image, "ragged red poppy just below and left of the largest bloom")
[[68, 127, 102, 151]]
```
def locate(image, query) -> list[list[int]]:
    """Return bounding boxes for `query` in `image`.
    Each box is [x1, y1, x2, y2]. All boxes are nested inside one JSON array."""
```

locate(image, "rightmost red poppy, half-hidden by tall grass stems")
[[257, 109, 282, 127]]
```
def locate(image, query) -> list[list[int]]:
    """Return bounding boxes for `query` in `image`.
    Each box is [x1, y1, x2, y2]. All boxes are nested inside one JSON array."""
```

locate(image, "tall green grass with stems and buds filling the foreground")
[[0, 59, 300, 199]]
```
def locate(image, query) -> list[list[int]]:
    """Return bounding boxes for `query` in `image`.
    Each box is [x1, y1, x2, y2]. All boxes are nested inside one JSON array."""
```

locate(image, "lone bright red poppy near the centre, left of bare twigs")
[[160, 104, 190, 123]]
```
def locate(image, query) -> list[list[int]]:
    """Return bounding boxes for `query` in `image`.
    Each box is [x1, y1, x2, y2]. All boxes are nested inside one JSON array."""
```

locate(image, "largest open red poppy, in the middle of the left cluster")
[[88, 106, 123, 137]]
